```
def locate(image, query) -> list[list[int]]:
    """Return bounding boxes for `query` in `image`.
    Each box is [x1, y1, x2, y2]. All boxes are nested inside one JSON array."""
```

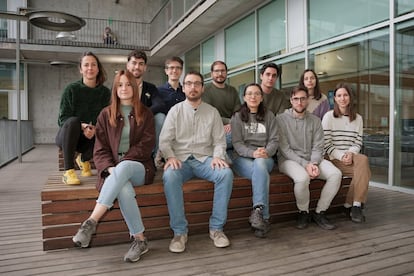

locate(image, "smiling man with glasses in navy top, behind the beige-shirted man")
[[154, 56, 185, 169]]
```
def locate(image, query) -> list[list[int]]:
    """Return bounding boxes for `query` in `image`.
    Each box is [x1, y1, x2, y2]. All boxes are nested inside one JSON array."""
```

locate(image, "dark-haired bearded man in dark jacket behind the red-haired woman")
[[126, 50, 165, 160]]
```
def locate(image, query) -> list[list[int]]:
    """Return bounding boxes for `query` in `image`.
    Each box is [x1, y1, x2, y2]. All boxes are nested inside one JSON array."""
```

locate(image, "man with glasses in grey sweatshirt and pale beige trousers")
[[276, 86, 342, 230]]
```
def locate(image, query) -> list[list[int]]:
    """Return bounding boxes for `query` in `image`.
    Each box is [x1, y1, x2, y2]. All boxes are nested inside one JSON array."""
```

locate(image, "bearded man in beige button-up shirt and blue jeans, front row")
[[160, 72, 233, 253]]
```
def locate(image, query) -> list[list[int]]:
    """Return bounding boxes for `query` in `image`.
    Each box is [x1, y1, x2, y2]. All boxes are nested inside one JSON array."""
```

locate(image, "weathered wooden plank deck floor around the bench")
[[0, 145, 414, 276]]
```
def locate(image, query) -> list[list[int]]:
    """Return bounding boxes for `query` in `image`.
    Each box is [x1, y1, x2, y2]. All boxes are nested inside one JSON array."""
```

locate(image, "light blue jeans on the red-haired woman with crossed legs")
[[96, 160, 145, 236]]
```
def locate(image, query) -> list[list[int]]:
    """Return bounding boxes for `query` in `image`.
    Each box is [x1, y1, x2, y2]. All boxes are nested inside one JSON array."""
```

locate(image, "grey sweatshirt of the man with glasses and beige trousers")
[[276, 108, 324, 167]]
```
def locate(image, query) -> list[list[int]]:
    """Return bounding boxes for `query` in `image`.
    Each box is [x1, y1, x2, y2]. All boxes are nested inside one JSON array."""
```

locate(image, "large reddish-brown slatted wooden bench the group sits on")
[[41, 170, 350, 250]]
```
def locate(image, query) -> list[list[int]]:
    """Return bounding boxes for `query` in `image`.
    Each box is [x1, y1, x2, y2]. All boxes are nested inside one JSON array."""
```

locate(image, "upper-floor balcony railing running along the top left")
[[0, 0, 205, 50]]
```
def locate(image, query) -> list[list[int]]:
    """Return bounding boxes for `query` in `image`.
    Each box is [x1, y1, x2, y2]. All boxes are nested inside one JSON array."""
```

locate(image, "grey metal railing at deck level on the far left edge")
[[0, 119, 34, 168]]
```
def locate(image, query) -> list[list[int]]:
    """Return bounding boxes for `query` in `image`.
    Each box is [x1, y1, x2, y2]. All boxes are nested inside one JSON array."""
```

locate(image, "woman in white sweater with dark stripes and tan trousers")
[[322, 83, 371, 223]]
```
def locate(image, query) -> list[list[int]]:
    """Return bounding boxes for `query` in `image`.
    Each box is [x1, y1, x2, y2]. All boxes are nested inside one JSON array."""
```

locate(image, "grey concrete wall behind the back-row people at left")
[[28, 61, 165, 144]]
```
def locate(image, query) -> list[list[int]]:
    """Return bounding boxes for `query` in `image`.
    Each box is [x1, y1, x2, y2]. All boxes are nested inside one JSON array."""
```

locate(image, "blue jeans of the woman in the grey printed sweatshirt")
[[232, 156, 274, 219]]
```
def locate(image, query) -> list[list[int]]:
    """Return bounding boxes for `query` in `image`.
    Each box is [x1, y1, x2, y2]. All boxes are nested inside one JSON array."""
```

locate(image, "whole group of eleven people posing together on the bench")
[[56, 50, 370, 262]]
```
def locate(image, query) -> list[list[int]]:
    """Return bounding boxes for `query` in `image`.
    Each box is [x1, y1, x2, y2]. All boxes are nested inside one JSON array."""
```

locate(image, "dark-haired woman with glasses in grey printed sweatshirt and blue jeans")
[[229, 83, 278, 237]]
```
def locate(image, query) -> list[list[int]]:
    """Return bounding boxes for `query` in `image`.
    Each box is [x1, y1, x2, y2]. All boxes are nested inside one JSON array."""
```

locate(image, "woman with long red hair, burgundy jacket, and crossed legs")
[[72, 70, 155, 262]]
